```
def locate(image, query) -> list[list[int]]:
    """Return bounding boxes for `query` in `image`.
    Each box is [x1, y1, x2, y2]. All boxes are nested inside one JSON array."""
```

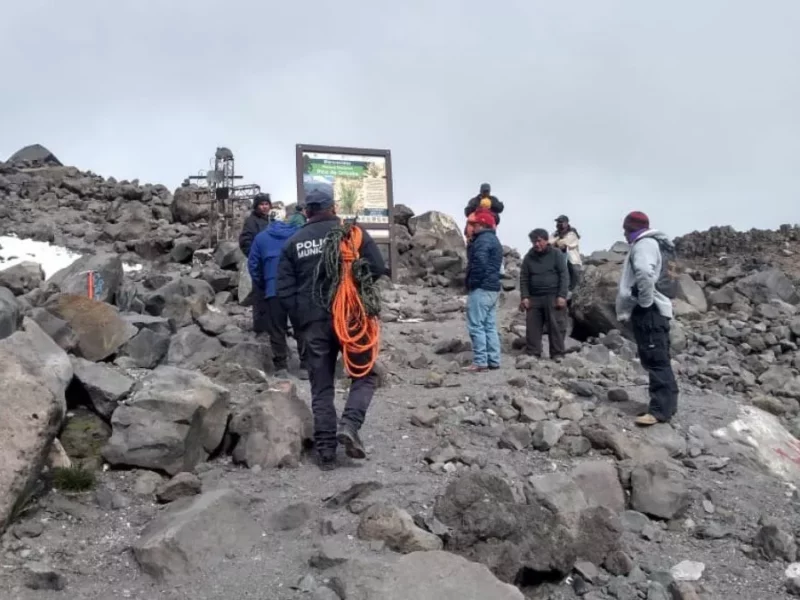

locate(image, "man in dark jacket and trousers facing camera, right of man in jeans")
[[519, 229, 569, 361]]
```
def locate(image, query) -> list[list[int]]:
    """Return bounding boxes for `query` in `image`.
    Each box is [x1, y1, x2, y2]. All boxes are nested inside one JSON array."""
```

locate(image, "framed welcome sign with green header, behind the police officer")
[[296, 144, 398, 279]]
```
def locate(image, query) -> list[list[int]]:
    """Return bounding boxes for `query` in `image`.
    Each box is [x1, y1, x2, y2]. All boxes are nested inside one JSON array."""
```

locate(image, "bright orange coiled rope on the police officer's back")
[[331, 225, 380, 379]]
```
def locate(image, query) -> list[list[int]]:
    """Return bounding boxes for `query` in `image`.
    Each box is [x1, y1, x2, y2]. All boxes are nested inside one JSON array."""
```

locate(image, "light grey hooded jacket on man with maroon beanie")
[[616, 229, 672, 322]]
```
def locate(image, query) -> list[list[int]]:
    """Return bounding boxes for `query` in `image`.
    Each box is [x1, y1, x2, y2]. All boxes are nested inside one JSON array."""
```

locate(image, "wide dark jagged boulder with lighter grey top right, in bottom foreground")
[[434, 466, 622, 583]]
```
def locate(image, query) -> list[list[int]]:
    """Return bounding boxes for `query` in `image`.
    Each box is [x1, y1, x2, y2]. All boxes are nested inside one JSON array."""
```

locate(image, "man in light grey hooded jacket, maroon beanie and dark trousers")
[[617, 211, 678, 427]]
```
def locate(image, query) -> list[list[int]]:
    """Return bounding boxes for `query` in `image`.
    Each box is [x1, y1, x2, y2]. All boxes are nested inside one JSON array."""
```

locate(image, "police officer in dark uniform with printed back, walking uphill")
[[277, 188, 386, 470]]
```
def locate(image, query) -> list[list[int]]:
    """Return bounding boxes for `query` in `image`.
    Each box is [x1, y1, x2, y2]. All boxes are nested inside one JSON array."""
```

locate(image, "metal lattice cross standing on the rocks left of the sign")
[[186, 147, 261, 247]]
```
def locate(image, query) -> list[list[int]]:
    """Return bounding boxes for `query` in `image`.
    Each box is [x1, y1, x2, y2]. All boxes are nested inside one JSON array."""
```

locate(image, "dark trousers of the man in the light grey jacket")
[[631, 305, 678, 421]]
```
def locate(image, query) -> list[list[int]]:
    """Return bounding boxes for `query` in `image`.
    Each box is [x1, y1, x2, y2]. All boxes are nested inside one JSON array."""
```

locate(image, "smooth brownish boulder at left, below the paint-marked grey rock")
[[46, 294, 137, 362]]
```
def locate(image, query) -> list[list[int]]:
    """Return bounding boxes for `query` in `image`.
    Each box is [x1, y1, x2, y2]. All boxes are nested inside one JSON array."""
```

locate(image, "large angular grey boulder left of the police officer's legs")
[[103, 366, 230, 475]]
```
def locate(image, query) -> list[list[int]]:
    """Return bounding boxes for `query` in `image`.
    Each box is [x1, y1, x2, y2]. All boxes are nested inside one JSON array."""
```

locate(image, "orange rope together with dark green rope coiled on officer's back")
[[323, 224, 380, 379]]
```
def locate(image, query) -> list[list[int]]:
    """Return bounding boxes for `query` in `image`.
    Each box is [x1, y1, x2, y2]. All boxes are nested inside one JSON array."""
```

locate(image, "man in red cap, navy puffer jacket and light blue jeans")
[[466, 208, 503, 373]]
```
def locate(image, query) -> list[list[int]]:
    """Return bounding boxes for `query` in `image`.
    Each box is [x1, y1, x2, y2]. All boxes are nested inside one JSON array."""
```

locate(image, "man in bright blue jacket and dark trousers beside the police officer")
[[247, 206, 306, 377]]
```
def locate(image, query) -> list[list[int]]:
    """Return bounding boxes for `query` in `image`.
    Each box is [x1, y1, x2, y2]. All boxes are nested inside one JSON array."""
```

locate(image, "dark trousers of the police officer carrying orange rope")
[[301, 321, 378, 451]]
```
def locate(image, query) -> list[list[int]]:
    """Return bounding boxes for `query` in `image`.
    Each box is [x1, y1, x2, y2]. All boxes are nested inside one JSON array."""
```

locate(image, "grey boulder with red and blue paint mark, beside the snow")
[[47, 254, 125, 304]]
